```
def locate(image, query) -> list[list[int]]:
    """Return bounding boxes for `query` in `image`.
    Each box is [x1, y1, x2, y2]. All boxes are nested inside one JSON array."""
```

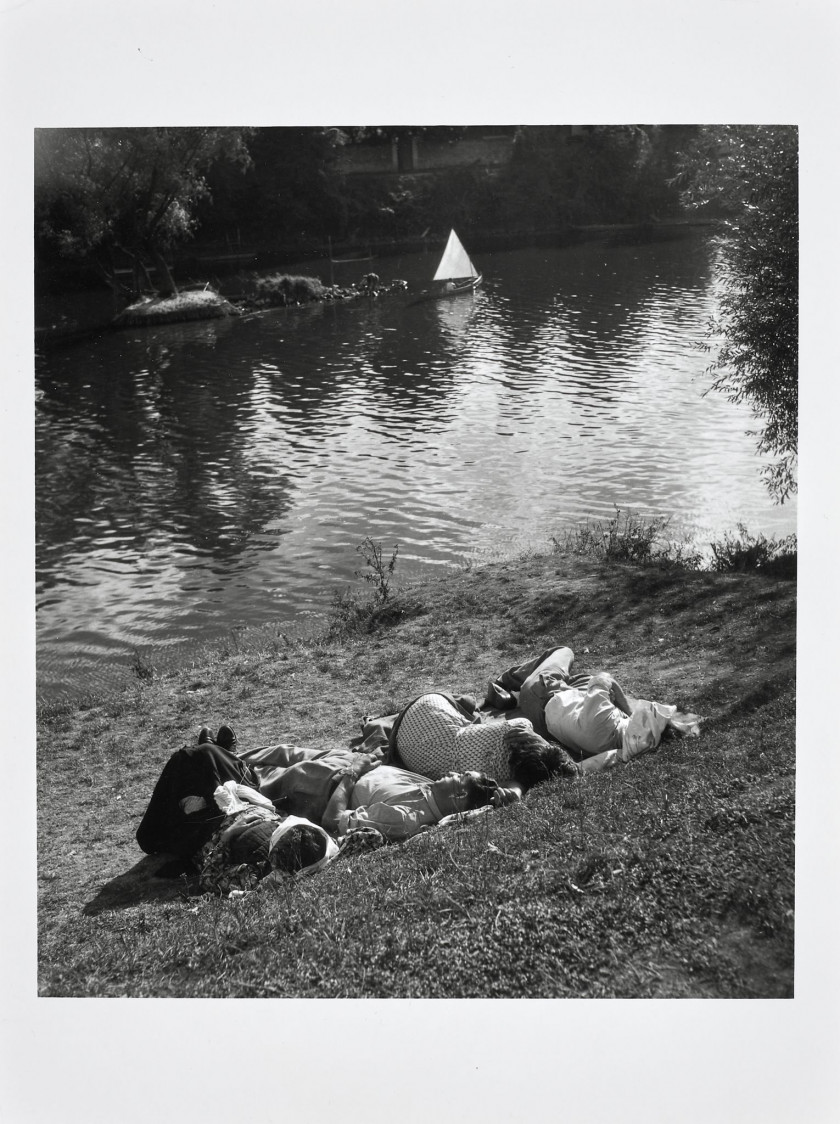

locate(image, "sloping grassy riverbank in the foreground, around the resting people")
[[38, 539, 796, 997]]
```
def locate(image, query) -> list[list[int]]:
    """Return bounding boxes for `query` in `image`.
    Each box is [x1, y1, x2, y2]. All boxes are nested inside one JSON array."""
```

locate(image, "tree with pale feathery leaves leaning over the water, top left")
[[35, 128, 250, 294]]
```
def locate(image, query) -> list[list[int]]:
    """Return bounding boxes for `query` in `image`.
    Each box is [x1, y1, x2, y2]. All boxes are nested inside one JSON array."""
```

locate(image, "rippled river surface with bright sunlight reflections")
[[36, 236, 796, 698]]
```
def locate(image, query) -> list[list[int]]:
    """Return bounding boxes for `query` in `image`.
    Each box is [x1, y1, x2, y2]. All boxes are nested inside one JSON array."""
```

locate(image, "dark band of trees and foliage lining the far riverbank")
[[36, 125, 697, 277]]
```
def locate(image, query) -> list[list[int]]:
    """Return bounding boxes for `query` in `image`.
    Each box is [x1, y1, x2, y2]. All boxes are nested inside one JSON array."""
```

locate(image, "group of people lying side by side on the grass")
[[137, 647, 699, 895]]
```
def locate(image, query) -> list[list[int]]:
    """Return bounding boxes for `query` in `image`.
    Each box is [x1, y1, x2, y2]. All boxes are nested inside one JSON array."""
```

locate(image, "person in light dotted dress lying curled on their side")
[[389, 694, 579, 794]]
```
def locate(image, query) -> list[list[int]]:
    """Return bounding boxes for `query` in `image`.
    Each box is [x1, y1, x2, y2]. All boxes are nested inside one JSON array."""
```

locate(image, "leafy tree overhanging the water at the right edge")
[[680, 125, 798, 502]]
